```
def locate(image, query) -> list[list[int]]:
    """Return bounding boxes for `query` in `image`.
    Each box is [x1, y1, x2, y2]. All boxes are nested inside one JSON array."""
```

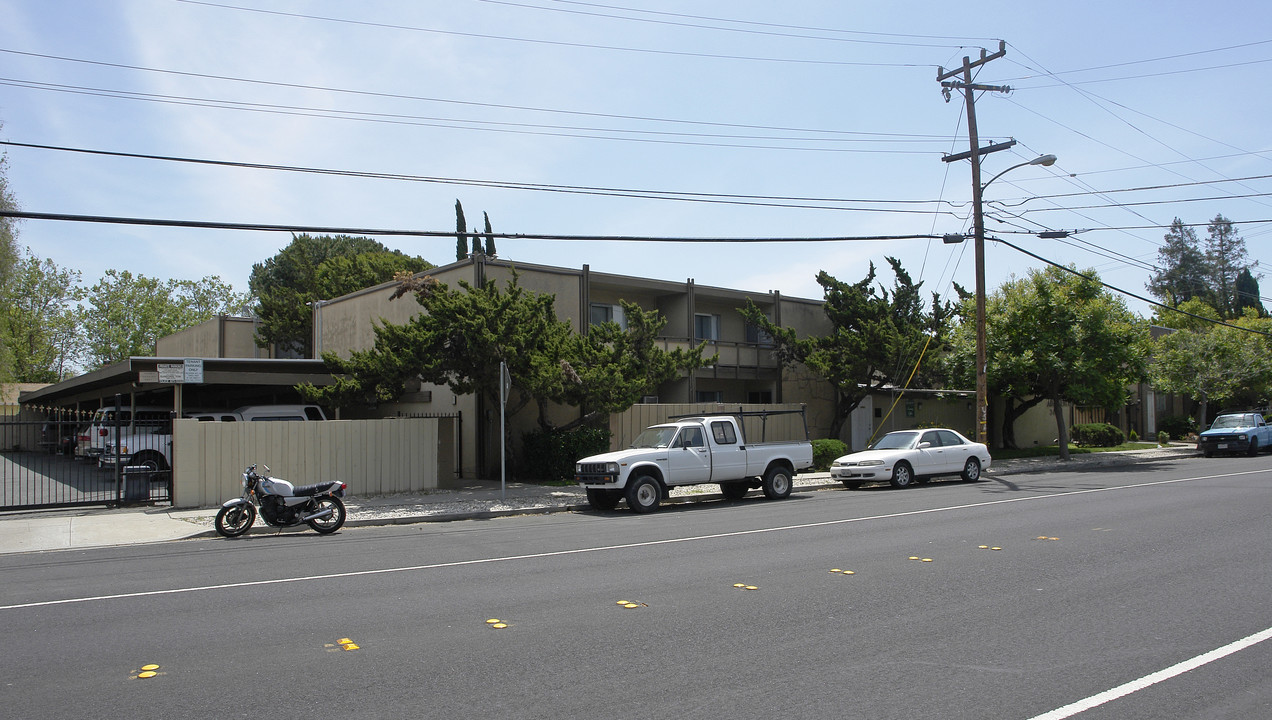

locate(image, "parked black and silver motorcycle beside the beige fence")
[[216, 464, 349, 538]]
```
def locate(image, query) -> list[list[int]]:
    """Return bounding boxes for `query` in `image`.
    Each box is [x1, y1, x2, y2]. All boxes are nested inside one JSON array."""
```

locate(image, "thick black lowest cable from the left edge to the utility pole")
[[0, 210, 941, 244]]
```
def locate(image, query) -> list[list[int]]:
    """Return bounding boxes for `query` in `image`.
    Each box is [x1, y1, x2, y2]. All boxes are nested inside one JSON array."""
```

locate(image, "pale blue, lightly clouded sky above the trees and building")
[[0, 0, 1272, 315]]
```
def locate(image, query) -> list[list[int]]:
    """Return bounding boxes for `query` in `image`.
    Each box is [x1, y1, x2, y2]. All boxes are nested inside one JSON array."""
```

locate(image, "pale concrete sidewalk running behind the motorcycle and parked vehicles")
[[0, 445, 1197, 555]]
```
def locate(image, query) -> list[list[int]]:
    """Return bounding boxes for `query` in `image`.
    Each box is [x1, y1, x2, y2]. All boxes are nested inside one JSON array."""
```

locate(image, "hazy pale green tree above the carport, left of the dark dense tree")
[[80, 270, 245, 369]]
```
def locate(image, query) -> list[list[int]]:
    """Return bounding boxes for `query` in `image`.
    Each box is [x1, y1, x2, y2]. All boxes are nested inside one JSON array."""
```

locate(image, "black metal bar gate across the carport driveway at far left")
[[0, 420, 172, 510]]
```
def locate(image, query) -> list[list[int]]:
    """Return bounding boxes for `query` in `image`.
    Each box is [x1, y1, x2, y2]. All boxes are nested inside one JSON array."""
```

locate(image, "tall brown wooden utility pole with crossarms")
[[936, 39, 1015, 445]]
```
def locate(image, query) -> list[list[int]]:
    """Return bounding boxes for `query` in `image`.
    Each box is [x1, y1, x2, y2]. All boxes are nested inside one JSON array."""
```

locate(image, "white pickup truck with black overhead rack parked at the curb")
[[575, 411, 813, 513]]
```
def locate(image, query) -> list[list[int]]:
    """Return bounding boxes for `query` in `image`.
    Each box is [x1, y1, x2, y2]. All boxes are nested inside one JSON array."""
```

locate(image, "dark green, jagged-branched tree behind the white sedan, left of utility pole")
[[739, 257, 949, 438]]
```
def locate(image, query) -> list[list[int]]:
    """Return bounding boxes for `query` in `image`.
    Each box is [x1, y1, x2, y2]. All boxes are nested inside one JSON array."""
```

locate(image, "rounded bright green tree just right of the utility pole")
[[957, 267, 1147, 459]]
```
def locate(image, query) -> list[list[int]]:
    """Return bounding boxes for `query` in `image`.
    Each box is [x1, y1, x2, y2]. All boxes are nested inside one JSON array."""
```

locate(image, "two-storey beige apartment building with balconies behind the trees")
[[313, 254, 832, 474]]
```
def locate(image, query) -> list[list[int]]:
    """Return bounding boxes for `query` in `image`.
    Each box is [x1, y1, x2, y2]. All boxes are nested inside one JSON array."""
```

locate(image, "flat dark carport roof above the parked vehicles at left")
[[18, 357, 332, 406]]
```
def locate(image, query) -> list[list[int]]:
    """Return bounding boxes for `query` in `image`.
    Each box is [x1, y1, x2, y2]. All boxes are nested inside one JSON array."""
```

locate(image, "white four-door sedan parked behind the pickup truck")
[[831, 427, 990, 490]]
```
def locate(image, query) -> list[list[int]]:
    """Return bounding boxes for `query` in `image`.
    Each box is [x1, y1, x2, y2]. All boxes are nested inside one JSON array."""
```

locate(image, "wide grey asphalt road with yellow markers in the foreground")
[[0, 455, 1272, 720]]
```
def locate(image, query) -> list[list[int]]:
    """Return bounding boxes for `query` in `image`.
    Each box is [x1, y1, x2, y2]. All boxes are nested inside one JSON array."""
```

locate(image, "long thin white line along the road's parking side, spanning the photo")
[[0, 471, 1267, 611]]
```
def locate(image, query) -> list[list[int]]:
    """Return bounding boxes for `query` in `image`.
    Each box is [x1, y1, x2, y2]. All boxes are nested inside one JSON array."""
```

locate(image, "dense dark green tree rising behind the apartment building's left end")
[[248, 234, 432, 357]]
